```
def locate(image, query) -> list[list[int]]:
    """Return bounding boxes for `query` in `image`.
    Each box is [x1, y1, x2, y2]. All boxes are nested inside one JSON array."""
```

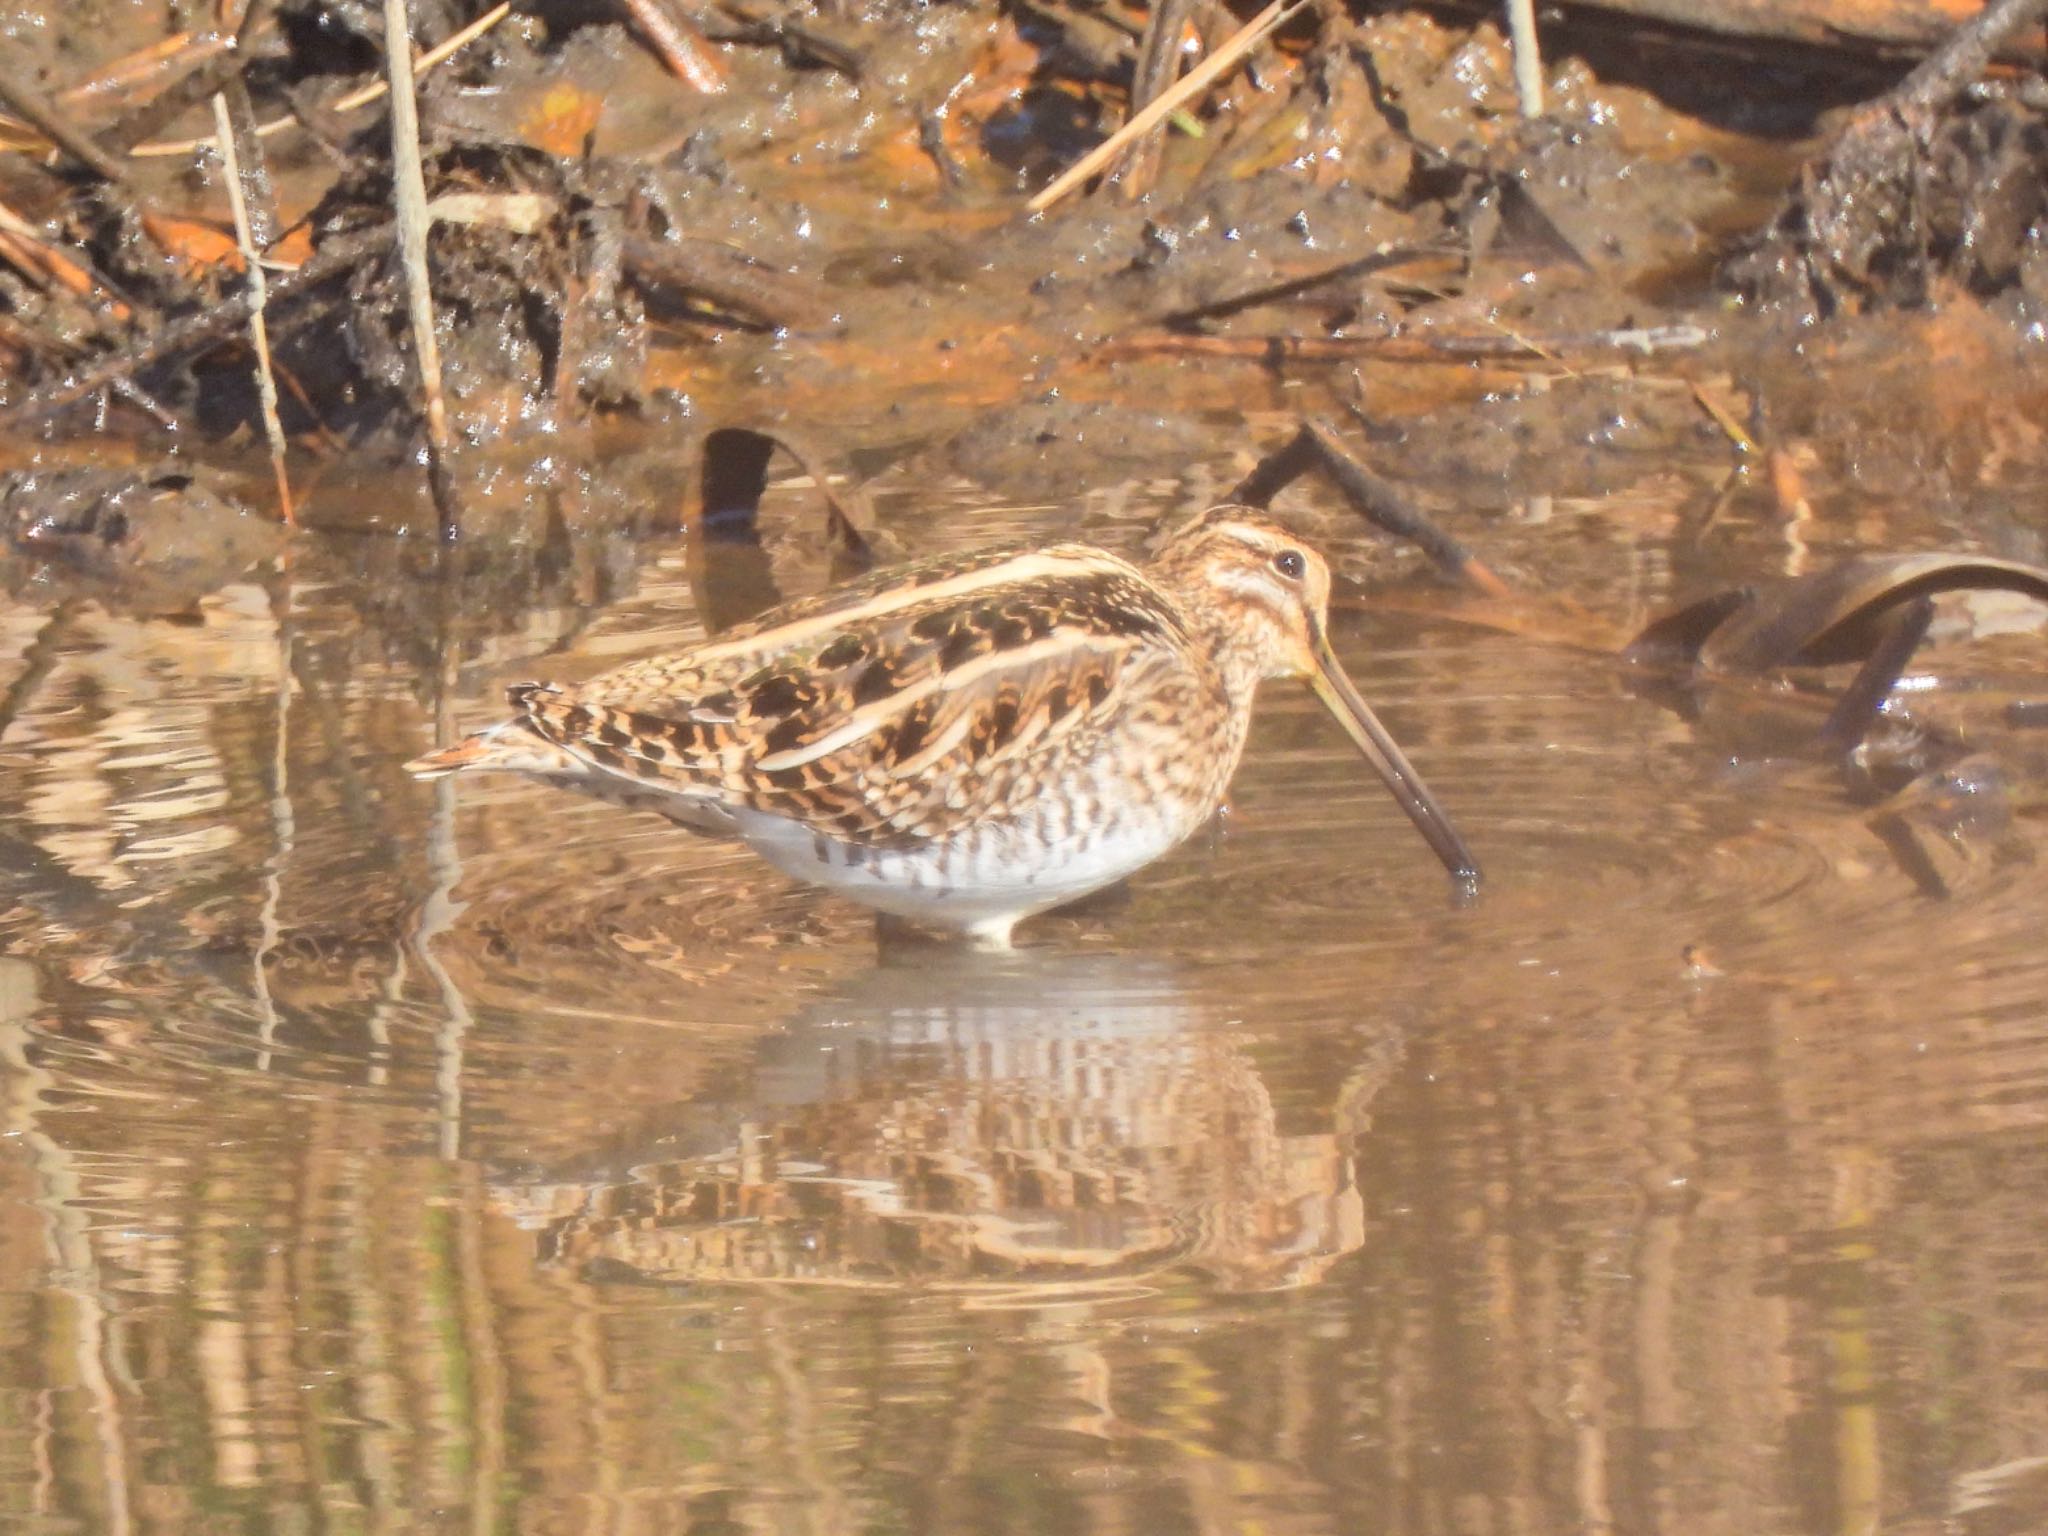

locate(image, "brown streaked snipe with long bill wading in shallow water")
[[408, 518, 1479, 946]]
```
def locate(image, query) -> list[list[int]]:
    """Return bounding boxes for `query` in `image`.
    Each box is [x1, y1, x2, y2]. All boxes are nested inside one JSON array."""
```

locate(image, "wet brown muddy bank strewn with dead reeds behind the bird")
[[0, 2, 2048, 565]]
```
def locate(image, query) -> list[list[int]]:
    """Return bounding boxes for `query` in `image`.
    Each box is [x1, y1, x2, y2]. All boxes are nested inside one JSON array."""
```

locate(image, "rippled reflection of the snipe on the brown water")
[[496, 950, 1397, 1300]]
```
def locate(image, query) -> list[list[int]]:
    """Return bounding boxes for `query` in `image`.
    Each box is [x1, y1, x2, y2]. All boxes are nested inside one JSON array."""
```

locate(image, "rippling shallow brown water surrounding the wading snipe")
[[0, 448, 2048, 1532]]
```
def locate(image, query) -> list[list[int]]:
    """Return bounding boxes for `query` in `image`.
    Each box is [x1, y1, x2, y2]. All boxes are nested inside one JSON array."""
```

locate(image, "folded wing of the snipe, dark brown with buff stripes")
[[512, 545, 1186, 844]]
